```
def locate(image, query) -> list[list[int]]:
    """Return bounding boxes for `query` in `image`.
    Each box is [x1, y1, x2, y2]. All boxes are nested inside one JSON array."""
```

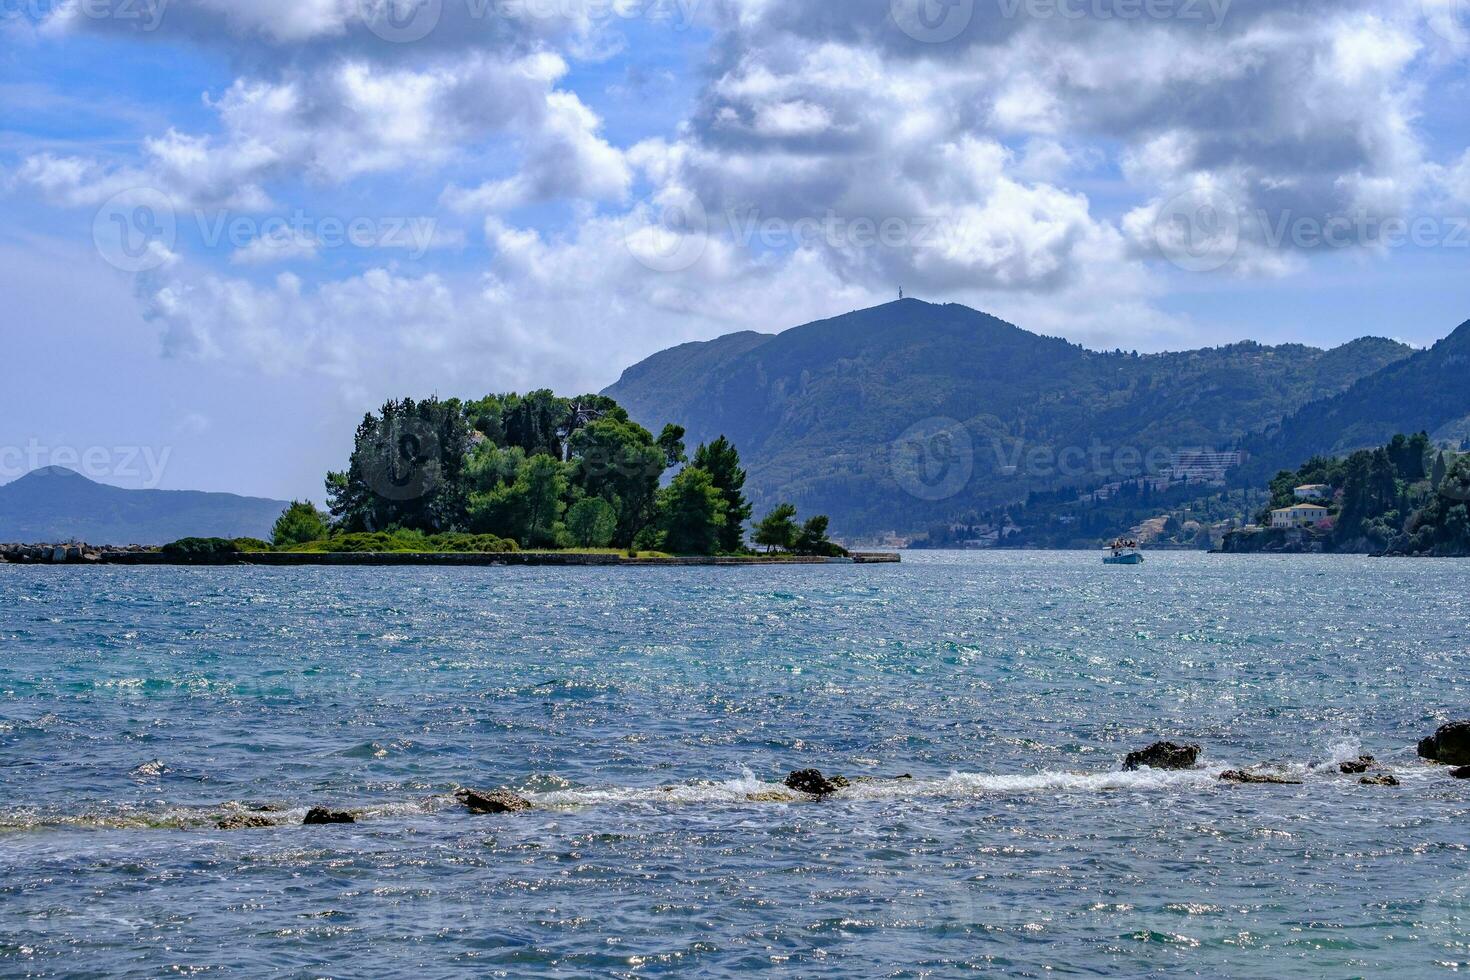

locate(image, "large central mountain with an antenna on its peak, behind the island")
[[606, 300, 1411, 535]]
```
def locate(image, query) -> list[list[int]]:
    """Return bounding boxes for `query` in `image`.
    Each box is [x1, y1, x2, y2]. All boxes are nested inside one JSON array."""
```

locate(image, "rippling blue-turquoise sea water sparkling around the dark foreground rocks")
[[0, 554, 1470, 977]]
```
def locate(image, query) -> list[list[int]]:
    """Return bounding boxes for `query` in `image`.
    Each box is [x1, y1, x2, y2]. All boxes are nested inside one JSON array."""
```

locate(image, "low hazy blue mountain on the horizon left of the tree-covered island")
[[0, 466, 287, 545]]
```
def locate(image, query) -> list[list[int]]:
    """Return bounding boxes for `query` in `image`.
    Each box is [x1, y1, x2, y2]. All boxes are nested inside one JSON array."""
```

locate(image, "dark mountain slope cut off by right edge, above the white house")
[[1247, 322, 1470, 476]]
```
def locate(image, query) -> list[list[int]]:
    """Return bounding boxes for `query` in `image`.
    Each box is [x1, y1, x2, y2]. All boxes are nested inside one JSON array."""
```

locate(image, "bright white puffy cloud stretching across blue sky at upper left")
[[18, 53, 629, 212]]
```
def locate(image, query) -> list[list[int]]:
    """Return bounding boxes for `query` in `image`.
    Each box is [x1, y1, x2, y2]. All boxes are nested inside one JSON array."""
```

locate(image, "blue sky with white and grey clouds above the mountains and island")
[[0, 0, 1470, 501]]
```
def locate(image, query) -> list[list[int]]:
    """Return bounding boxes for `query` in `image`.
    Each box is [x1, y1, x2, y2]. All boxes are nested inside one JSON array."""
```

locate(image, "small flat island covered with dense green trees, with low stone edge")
[[0, 391, 900, 566]]
